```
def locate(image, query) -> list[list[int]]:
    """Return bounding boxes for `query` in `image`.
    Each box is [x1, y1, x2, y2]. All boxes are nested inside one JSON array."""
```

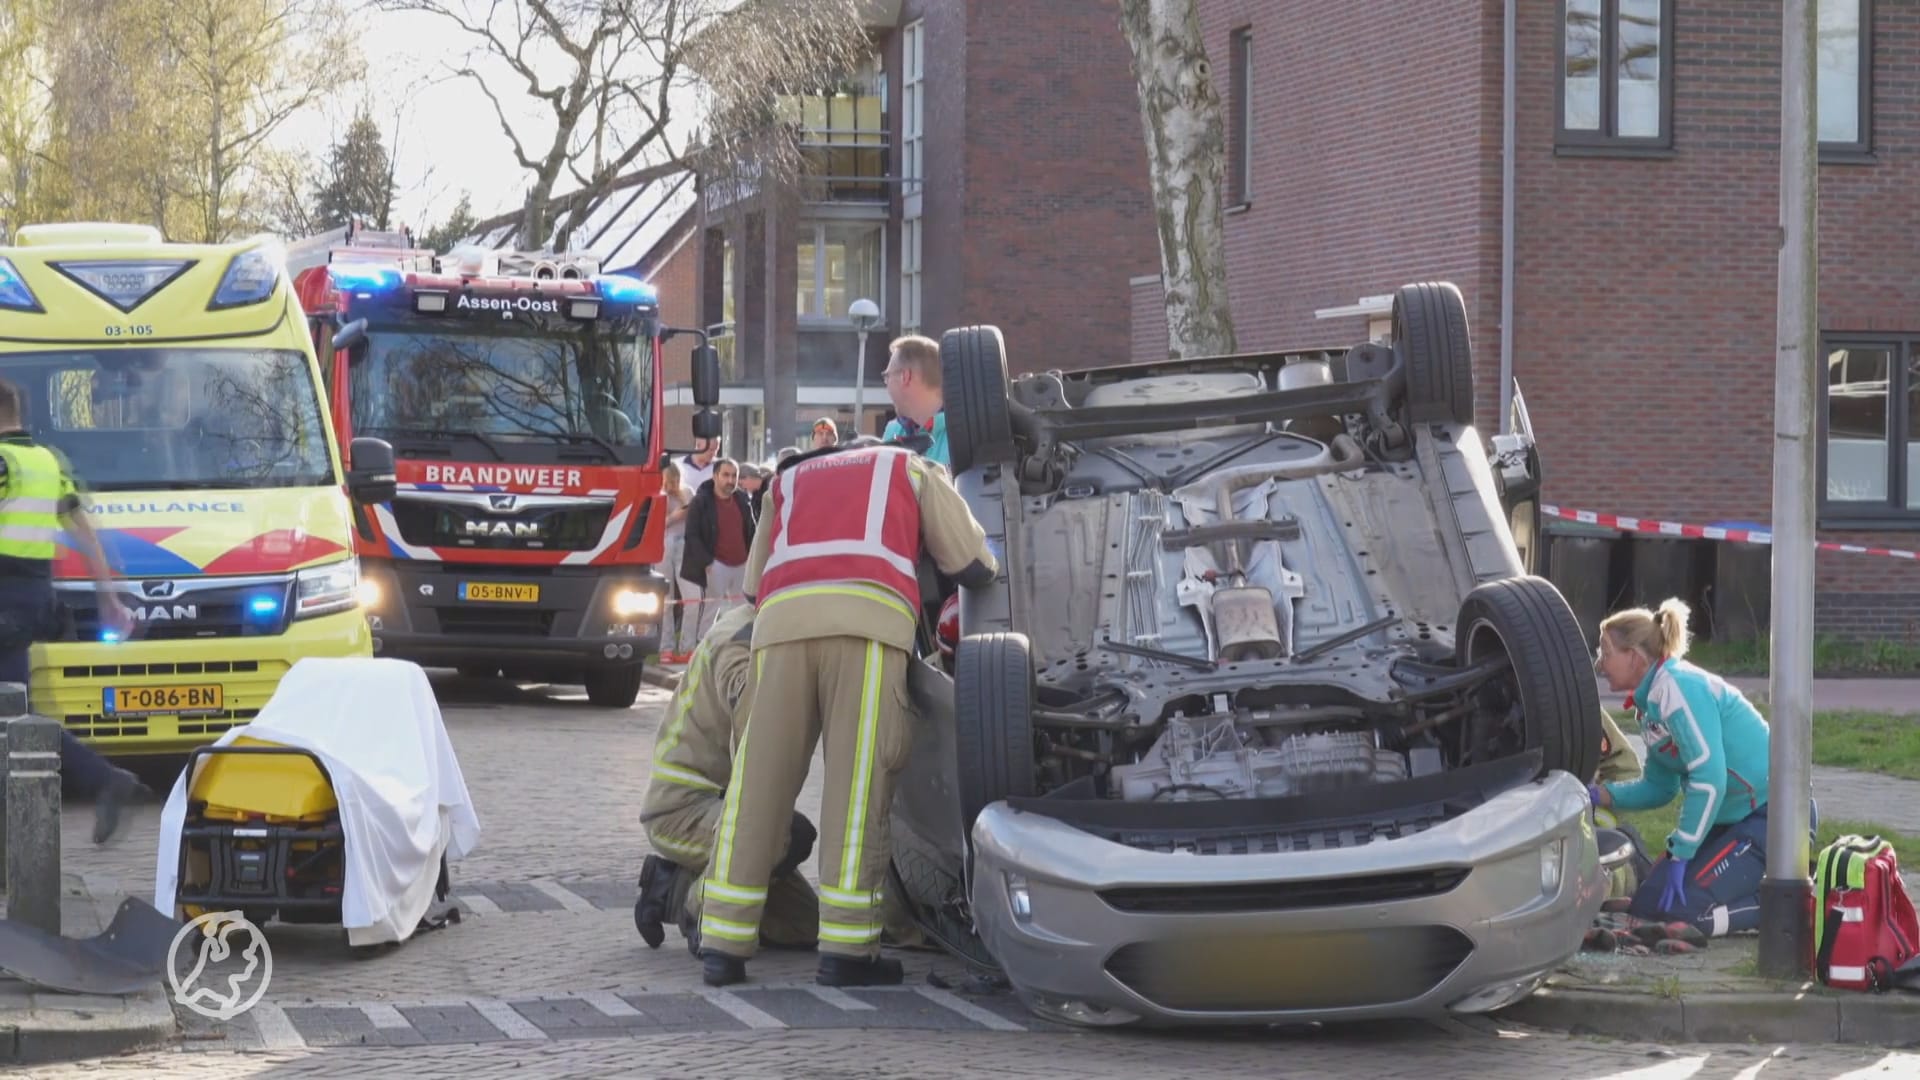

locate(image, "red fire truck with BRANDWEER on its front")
[[288, 225, 720, 709]]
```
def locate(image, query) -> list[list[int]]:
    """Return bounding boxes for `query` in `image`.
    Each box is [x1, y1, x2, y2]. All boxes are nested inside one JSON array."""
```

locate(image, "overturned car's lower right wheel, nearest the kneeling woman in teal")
[[1453, 577, 1605, 782]]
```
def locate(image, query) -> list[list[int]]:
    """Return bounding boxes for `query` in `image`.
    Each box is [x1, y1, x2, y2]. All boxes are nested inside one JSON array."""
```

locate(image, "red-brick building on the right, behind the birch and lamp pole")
[[1133, 0, 1920, 640]]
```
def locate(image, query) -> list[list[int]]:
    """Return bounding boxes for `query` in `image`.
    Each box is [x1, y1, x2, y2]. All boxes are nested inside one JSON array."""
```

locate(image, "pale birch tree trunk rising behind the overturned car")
[[1119, 0, 1236, 359]]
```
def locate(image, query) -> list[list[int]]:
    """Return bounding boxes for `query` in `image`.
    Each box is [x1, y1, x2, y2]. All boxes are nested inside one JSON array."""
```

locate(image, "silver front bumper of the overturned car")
[[970, 773, 1607, 1026]]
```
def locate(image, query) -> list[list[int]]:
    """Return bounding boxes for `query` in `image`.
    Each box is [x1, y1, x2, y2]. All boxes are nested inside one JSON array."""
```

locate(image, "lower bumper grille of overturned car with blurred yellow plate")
[[1106, 926, 1473, 1013]]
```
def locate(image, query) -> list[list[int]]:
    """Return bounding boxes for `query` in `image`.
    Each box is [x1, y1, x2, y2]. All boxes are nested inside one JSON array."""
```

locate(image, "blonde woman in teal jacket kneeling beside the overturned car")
[[1588, 600, 1768, 938]]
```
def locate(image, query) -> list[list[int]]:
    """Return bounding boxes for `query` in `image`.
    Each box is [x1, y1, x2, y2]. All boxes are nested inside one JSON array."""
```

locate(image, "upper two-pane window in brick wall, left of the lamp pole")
[[1559, 0, 1674, 150]]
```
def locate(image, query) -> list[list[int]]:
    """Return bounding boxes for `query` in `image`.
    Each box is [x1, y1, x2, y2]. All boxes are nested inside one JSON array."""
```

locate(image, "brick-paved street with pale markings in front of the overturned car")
[[41, 676, 1920, 1080]]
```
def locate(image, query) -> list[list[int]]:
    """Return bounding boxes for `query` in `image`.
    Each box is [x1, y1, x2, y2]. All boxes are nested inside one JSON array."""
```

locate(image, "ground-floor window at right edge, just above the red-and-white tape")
[[1820, 334, 1920, 525]]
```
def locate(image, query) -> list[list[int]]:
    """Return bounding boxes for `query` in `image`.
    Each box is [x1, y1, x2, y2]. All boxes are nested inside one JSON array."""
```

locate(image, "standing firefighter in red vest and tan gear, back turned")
[[701, 444, 996, 986]]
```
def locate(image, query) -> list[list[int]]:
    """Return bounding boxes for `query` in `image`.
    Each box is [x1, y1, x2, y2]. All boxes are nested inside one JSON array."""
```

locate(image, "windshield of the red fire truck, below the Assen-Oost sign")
[[349, 319, 653, 457]]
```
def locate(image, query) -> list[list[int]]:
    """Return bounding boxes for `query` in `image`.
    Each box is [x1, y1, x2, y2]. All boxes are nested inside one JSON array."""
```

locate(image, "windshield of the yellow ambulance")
[[0, 348, 340, 492]]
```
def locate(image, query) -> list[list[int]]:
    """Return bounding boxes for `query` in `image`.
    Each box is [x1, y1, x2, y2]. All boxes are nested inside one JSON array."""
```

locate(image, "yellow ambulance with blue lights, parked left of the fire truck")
[[0, 223, 394, 755]]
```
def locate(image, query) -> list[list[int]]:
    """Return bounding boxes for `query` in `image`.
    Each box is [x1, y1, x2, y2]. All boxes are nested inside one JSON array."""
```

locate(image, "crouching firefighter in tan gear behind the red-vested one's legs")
[[634, 603, 820, 955]]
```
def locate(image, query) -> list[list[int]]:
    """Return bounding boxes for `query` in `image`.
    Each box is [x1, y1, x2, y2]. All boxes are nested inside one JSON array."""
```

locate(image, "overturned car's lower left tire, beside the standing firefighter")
[[954, 634, 1033, 830]]
